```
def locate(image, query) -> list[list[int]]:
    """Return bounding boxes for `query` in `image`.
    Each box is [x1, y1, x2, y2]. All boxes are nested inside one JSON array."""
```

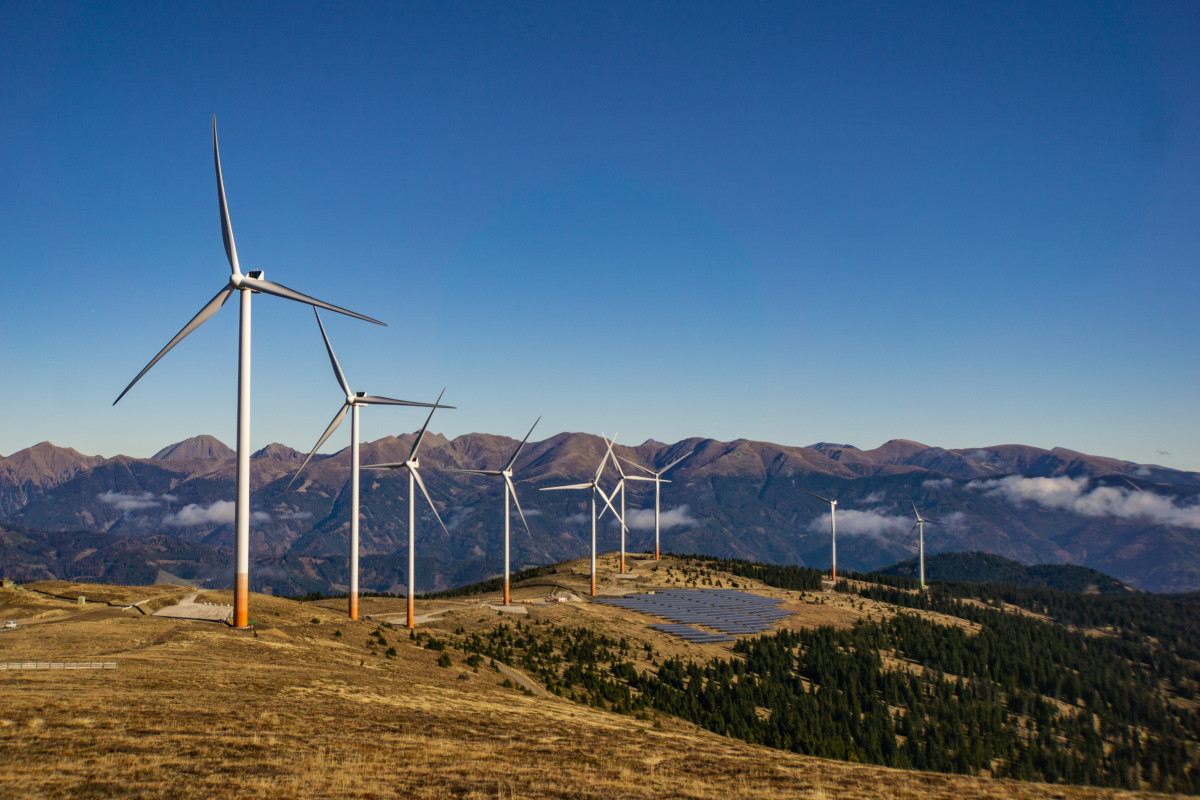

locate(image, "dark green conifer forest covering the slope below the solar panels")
[[451, 584, 1200, 793]]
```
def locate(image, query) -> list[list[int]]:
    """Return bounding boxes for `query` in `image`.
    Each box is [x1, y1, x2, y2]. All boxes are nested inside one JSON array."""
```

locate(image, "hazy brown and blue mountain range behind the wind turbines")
[[0, 433, 1200, 594]]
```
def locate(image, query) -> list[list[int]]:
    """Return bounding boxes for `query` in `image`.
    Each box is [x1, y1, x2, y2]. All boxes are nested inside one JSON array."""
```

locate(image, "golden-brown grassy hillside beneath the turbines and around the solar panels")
[[0, 555, 1194, 799]]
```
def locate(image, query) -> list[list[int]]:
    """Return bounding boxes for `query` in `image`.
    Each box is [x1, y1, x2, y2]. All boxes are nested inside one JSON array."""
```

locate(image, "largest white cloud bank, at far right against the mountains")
[[967, 475, 1200, 530]]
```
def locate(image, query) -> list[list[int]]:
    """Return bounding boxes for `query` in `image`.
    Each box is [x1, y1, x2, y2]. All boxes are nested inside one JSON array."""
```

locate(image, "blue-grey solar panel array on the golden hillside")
[[596, 589, 791, 642]]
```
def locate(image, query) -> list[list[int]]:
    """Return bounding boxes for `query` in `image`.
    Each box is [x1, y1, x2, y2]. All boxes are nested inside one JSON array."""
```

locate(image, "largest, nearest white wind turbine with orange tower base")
[[113, 115, 384, 627]]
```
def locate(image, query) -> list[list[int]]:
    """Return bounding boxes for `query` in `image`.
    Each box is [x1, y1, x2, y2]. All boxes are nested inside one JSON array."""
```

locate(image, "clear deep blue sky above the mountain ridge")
[[0, 1, 1200, 469]]
